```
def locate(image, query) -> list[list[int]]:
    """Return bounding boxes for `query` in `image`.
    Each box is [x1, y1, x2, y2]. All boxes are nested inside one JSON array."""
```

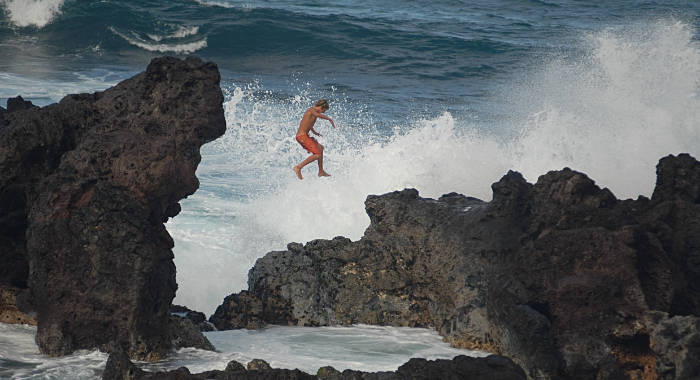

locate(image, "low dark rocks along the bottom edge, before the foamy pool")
[[102, 353, 526, 380]]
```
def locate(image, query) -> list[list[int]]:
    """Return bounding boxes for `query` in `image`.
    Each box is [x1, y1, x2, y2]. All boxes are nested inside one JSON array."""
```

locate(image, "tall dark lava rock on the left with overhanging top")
[[0, 57, 225, 360]]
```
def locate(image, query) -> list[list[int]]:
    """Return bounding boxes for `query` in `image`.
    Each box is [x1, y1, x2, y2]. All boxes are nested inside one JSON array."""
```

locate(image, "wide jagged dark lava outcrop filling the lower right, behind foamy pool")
[[210, 154, 700, 379]]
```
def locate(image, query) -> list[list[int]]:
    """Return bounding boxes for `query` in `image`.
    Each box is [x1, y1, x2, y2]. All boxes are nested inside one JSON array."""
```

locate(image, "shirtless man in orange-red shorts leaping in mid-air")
[[294, 99, 335, 179]]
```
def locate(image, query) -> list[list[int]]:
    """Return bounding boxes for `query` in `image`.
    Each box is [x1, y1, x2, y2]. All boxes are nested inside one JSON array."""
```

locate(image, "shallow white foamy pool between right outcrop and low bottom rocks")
[[143, 325, 486, 374]]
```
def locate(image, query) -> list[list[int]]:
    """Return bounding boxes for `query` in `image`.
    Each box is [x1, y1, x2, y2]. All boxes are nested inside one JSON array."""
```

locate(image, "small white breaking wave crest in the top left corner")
[[0, 0, 64, 28]]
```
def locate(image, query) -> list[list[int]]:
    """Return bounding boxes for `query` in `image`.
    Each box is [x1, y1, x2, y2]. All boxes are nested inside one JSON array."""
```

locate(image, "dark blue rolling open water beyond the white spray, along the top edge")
[[0, 0, 700, 120]]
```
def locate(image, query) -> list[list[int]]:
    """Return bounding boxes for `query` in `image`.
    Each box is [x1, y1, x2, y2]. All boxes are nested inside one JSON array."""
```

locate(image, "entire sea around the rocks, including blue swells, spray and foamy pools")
[[0, 0, 700, 379]]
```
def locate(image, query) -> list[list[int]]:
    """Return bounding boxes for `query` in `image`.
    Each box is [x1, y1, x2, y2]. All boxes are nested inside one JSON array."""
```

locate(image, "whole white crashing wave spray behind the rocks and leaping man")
[[168, 21, 700, 314]]
